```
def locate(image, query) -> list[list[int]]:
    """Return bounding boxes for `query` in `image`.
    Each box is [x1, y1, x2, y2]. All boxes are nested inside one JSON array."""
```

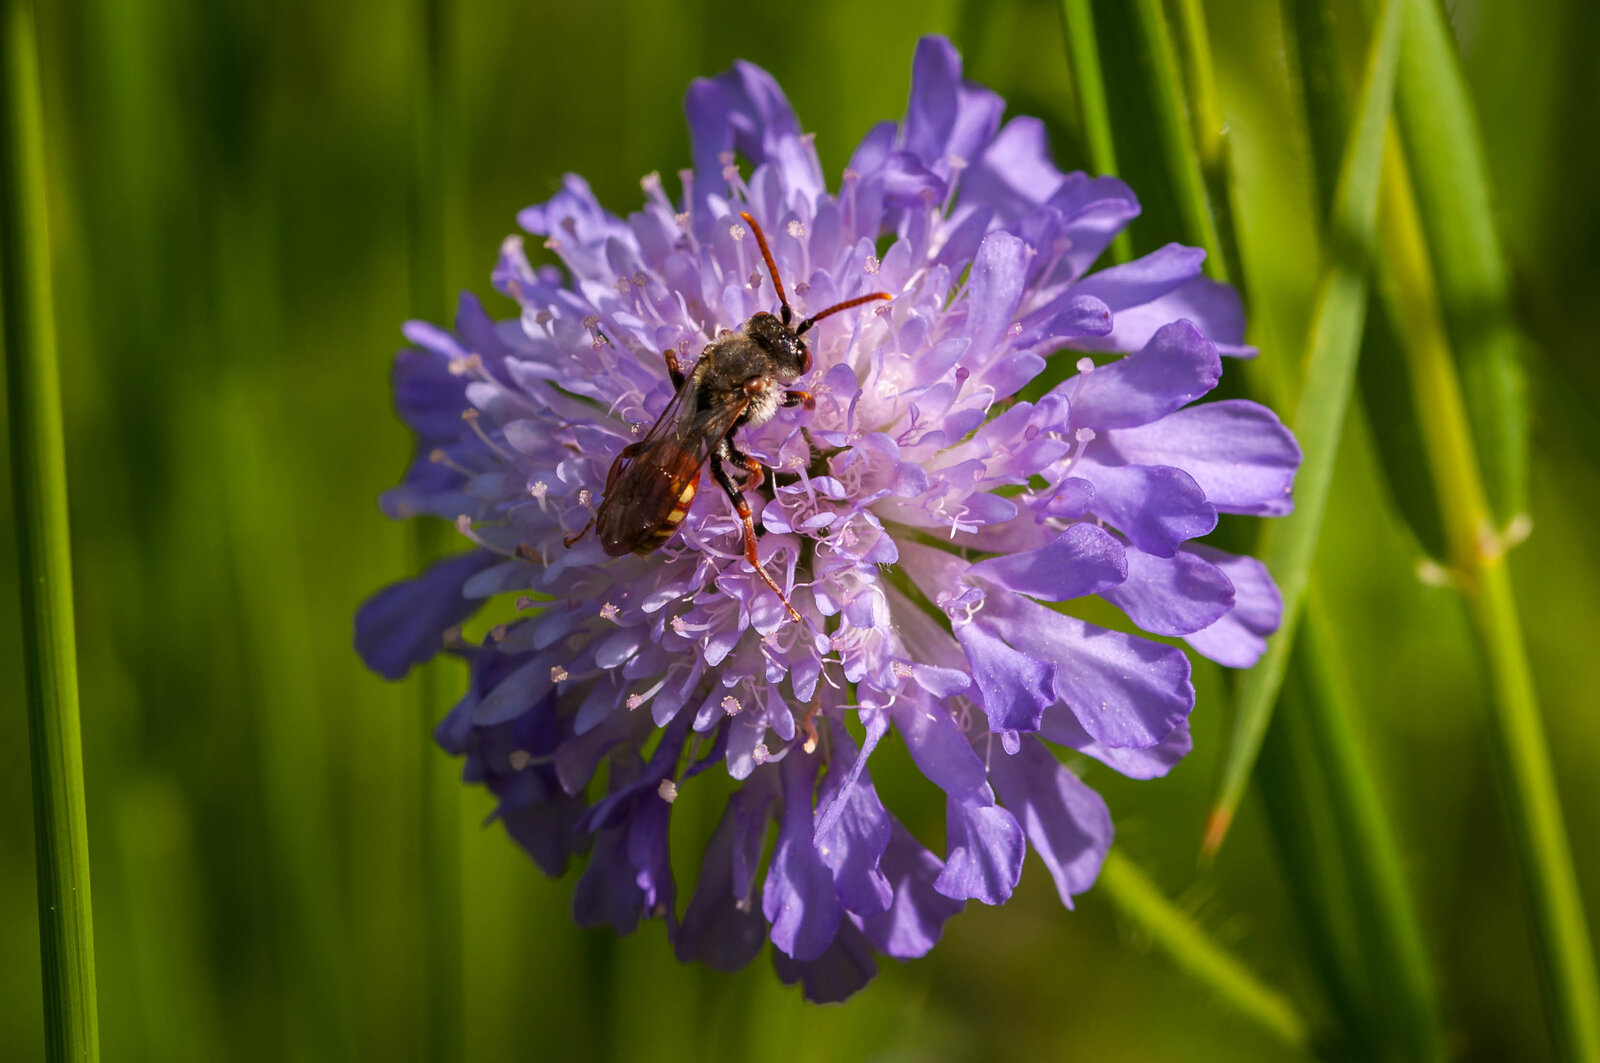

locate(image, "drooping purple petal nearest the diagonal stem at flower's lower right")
[[992, 735, 1112, 908]]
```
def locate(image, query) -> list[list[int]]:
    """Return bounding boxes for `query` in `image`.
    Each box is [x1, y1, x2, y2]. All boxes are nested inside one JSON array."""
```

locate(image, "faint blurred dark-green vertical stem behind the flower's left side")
[[410, 0, 466, 1063]]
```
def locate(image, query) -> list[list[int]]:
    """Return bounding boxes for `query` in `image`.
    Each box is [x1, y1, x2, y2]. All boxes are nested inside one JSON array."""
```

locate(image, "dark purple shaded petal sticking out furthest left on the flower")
[[355, 551, 501, 679]]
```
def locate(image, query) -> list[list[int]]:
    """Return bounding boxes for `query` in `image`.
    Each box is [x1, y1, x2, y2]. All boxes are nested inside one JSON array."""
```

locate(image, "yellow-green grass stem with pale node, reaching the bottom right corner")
[[1381, 154, 1600, 1061]]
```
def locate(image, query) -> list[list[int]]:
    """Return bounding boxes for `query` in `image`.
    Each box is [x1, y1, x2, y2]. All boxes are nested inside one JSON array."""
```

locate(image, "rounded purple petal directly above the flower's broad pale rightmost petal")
[[1056, 322, 1222, 431]]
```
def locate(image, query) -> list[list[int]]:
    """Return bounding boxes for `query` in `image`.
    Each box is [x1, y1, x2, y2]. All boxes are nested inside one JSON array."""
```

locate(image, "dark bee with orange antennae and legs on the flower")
[[566, 213, 891, 623]]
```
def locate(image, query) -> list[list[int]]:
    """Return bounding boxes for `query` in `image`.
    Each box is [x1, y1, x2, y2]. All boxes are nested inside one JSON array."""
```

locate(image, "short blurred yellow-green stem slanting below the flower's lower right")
[[1096, 848, 1310, 1047]]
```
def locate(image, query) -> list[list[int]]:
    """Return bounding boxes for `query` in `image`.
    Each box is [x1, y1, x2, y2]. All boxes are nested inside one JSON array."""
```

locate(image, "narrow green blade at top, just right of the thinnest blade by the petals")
[[1133, 0, 1238, 280]]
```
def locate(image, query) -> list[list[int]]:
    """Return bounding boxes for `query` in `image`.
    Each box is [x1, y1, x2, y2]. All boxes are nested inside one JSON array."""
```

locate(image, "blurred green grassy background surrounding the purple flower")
[[0, 0, 1600, 1060]]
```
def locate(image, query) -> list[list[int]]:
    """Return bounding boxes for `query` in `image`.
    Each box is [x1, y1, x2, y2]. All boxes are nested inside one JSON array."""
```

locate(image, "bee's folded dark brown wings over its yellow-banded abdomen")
[[595, 384, 750, 557]]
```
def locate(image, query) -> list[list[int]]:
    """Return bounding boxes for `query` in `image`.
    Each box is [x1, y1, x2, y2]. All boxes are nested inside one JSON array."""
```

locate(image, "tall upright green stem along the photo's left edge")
[[0, 0, 99, 1061]]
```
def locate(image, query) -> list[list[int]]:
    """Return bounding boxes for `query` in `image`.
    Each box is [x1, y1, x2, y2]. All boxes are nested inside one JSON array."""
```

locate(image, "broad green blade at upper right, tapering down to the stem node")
[[1395, 0, 1528, 532]]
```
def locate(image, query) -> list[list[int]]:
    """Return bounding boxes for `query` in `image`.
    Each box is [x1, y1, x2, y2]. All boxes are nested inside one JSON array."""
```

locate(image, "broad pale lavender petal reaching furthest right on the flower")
[[1091, 399, 1301, 515]]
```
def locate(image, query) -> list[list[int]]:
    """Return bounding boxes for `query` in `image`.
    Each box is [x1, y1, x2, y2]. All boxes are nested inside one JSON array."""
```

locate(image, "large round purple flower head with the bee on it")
[[357, 31, 1299, 1001]]
